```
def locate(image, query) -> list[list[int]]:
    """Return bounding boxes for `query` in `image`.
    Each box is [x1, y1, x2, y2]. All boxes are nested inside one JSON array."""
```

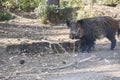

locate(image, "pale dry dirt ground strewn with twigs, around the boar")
[[0, 5, 120, 80]]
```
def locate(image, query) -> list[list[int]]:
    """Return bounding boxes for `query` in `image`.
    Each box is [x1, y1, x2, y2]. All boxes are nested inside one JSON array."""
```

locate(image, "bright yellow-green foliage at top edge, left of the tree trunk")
[[3, 0, 44, 11]]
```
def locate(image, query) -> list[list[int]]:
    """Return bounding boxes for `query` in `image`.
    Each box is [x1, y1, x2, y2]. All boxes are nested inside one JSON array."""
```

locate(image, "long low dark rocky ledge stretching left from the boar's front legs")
[[6, 41, 80, 54]]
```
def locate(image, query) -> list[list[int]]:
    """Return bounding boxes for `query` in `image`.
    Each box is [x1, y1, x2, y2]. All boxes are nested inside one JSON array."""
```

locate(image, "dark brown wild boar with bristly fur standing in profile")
[[66, 16, 120, 52]]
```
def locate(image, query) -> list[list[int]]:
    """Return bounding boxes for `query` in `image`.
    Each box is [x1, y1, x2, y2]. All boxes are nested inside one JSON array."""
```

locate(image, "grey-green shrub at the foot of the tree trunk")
[[35, 2, 78, 23]]
